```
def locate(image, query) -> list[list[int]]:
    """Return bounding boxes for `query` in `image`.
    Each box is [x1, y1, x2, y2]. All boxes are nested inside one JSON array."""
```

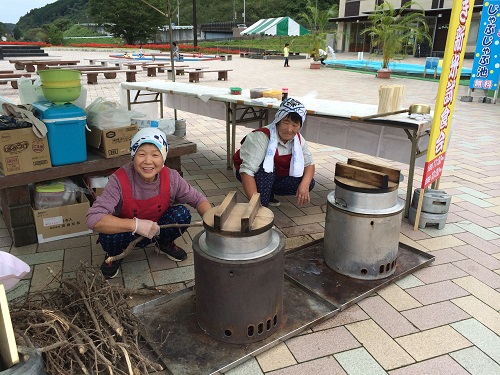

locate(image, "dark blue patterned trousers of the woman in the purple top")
[[99, 205, 191, 256]]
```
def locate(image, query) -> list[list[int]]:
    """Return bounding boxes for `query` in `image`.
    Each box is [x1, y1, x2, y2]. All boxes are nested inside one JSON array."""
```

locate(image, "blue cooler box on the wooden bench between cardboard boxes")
[[33, 102, 87, 166]]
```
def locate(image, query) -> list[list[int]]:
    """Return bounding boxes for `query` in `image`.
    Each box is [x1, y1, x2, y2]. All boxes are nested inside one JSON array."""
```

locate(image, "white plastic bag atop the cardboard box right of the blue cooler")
[[85, 98, 130, 130]]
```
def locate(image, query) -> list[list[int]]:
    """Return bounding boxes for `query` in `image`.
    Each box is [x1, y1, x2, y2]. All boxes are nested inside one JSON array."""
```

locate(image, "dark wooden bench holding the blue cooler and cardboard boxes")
[[0, 135, 197, 247]]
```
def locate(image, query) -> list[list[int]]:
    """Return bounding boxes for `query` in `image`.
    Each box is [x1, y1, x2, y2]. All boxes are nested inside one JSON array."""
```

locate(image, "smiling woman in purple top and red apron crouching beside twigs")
[[87, 128, 211, 278]]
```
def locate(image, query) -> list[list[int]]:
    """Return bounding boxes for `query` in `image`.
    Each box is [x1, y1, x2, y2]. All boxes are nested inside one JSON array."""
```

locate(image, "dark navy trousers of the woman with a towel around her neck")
[[235, 165, 316, 207]]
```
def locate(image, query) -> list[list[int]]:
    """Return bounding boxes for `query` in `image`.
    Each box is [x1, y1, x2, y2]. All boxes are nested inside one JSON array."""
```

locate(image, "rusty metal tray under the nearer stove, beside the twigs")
[[133, 280, 339, 375]]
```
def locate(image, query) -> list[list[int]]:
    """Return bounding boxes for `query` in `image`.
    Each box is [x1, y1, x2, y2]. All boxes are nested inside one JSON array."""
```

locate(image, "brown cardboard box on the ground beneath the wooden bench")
[[33, 192, 92, 243]]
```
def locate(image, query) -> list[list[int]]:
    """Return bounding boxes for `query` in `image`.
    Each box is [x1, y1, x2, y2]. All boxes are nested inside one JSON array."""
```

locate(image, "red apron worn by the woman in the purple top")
[[115, 167, 170, 222]]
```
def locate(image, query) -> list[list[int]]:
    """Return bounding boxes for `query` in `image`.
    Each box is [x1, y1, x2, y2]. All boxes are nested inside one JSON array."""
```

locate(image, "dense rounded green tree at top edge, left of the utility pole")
[[89, 0, 167, 44]]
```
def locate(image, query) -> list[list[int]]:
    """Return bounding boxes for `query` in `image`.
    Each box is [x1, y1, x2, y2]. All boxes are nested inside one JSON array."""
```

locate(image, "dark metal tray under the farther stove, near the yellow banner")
[[285, 240, 435, 310]]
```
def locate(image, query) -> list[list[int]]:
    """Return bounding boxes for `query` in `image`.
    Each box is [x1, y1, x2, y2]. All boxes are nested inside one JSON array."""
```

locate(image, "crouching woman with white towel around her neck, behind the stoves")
[[233, 98, 315, 207]]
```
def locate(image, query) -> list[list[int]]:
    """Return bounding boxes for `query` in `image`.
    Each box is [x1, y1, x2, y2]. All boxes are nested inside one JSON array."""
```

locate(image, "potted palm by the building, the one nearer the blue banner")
[[361, 1, 432, 78]]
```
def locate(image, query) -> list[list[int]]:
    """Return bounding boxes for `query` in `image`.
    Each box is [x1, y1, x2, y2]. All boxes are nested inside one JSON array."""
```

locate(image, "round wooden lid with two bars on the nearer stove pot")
[[203, 191, 274, 236]]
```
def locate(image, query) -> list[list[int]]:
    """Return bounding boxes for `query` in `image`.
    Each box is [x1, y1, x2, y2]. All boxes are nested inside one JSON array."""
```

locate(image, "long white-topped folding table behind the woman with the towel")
[[121, 81, 431, 216]]
